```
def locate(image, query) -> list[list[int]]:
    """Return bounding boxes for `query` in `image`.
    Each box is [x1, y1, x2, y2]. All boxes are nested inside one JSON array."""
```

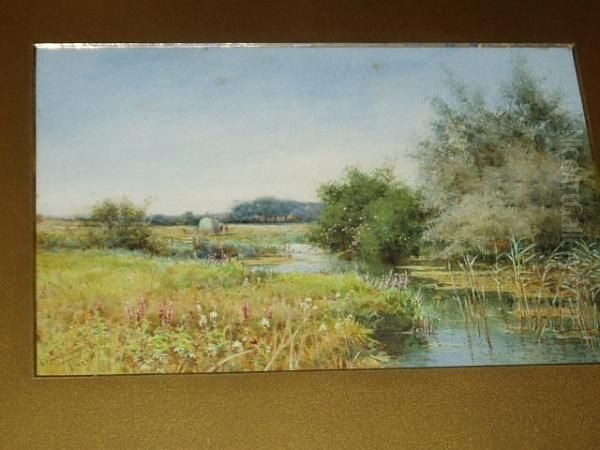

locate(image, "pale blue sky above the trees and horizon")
[[36, 47, 581, 215]]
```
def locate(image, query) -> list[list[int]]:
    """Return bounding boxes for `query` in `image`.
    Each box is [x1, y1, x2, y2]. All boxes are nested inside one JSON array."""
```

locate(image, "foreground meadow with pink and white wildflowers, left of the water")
[[37, 250, 418, 375]]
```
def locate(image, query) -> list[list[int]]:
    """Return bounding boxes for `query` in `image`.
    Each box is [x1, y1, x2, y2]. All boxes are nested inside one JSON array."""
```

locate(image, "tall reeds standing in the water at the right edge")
[[448, 238, 600, 340]]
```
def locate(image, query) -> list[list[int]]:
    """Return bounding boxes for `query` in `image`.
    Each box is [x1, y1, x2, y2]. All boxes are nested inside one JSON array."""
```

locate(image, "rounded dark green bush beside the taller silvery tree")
[[311, 166, 423, 264]]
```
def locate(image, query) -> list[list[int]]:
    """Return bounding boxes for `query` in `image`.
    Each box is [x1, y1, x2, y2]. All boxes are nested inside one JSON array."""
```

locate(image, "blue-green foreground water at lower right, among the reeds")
[[378, 295, 600, 367]]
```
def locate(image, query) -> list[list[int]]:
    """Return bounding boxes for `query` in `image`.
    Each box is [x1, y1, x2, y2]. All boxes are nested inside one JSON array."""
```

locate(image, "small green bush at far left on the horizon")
[[91, 198, 151, 250]]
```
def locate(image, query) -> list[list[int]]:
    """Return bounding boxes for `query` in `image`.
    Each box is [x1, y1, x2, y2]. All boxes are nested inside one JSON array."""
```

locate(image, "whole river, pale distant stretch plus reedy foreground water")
[[247, 244, 600, 367]]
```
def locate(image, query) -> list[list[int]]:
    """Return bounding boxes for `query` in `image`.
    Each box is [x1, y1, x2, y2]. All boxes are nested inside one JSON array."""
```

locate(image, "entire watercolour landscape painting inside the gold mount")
[[35, 44, 600, 376]]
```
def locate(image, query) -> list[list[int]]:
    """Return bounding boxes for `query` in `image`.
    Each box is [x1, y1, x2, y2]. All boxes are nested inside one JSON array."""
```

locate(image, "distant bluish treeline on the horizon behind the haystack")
[[148, 197, 323, 226]]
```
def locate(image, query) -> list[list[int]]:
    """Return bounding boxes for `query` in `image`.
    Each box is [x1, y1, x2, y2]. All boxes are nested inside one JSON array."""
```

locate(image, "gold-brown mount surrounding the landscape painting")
[[0, 0, 600, 448]]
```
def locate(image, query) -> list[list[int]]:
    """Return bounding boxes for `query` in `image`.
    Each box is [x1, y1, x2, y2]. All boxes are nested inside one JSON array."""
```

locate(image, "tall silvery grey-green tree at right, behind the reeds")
[[416, 59, 600, 254]]
